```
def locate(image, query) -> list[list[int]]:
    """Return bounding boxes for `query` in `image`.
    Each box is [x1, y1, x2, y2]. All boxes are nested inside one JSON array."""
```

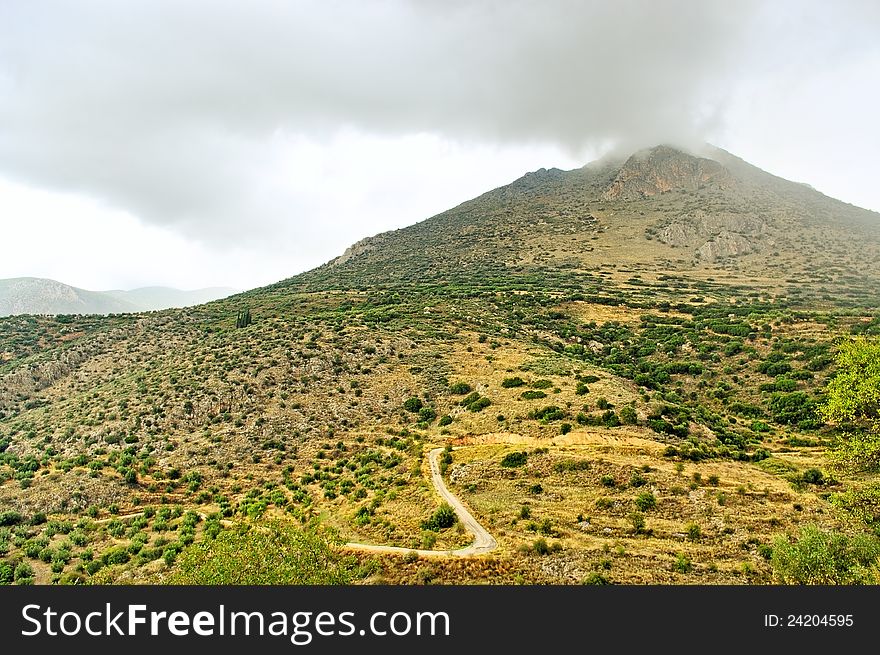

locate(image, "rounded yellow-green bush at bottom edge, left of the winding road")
[[168, 521, 352, 585]]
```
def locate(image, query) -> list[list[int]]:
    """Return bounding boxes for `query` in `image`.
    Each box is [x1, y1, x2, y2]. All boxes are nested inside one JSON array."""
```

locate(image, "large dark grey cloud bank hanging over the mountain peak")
[[0, 0, 870, 243]]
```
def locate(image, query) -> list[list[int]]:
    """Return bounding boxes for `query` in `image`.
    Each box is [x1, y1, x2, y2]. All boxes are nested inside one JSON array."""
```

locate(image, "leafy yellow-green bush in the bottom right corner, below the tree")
[[770, 525, 880, 585]]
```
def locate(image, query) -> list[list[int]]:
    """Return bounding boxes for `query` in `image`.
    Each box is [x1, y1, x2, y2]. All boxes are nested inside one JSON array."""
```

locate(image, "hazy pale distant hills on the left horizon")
[[0, 277, 237, 316]]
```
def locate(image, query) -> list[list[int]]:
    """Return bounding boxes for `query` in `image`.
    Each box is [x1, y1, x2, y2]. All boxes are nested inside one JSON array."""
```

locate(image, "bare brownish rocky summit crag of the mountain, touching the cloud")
[[604, 145, 733, 200]]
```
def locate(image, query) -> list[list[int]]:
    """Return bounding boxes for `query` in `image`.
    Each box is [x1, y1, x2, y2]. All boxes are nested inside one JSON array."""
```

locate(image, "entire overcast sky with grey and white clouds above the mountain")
[[0, 0, 880, 289]]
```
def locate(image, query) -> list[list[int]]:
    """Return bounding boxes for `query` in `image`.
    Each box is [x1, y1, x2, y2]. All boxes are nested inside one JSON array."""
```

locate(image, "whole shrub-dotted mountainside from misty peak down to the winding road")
[[0, 146, 880, 584]]
